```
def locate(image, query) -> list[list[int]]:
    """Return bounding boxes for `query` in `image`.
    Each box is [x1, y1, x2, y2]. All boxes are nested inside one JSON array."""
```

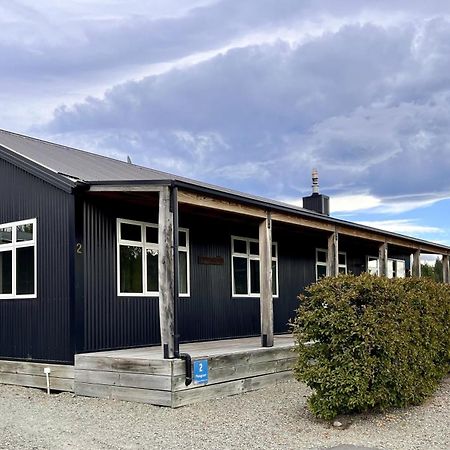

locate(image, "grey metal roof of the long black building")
[[0, 129, 450, 253]]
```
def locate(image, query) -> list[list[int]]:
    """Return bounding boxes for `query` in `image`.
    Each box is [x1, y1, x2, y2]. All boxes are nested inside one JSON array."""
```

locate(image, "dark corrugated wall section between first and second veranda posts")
[[179, 213, 260, 342]]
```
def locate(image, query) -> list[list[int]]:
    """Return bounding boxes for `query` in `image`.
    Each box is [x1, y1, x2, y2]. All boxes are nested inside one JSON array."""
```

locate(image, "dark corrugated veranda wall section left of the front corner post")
[[83, 199, 160, 351]]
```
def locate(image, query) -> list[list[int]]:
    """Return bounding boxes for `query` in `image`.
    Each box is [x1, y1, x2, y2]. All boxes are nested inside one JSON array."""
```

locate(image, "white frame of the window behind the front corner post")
[[116, 218, 191, 298]]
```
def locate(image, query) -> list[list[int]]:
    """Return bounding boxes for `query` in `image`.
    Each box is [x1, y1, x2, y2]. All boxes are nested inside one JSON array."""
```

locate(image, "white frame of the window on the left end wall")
[[0, 217, 38, 300]]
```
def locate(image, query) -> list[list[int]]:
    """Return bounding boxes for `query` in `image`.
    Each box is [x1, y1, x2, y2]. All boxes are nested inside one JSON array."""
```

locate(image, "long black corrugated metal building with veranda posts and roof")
[[0, 131, 450, 364]]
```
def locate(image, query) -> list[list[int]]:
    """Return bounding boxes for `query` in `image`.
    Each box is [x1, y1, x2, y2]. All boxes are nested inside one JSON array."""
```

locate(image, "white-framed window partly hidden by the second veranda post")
[[231, 236, 278, 297]]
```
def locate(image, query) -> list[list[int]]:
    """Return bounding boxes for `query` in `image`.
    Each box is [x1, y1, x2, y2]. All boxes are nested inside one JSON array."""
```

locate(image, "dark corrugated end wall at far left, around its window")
[[0, 160, 73, 362]]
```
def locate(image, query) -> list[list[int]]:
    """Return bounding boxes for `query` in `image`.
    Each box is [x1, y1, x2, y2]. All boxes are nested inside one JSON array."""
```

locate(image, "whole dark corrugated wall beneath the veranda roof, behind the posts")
[[80, 198, 412, 351]]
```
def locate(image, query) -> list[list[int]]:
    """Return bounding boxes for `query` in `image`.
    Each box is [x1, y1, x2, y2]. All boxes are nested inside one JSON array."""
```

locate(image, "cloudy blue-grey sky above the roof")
[[0, 0, 450, 253]]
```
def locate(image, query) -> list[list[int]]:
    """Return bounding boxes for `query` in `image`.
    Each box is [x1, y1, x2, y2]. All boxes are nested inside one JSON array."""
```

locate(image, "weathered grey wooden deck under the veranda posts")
[[75, 335, 295, 408]]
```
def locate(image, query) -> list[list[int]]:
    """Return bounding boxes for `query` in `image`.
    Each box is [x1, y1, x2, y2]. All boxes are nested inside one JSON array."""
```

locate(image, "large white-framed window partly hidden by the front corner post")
[[117, 219, 190, 297]]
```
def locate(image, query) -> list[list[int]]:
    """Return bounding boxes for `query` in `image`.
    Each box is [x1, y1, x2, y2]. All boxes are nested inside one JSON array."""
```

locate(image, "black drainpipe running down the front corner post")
[[171, 185, 192, 386]]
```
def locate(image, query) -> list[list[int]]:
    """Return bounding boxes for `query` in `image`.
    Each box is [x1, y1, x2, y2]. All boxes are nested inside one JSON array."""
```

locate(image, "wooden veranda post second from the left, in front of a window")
[[259, 213, 273, 347]]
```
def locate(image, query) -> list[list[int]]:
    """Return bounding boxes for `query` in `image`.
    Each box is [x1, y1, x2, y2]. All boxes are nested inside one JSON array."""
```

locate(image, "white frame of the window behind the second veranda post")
[[231, 235, 280, 298]]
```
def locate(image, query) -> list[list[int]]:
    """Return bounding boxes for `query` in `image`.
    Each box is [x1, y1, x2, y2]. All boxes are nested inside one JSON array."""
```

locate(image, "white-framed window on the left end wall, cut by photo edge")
[[0, 219, 37, 299]]
